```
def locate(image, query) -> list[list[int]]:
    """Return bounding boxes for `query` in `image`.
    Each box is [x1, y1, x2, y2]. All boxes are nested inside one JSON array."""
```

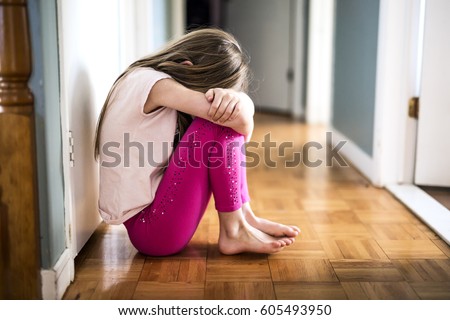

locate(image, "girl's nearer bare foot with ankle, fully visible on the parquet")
[[219, 209, 294, 255]]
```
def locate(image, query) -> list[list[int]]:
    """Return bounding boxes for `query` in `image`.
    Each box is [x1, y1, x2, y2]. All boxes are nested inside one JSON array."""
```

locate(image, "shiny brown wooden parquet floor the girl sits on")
[[64, 115, 450, 300]]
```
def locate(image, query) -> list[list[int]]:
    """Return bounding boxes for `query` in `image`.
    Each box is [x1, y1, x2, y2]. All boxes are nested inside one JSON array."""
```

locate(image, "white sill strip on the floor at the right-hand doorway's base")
[[386, 184, 450, 245]]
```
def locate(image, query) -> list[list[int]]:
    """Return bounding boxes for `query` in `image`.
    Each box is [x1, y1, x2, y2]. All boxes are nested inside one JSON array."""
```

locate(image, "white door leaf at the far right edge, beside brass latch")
[[415, 0, 450, 187]]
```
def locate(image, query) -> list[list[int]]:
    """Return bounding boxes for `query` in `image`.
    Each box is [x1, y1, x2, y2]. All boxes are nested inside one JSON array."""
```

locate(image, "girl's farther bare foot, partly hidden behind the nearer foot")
[[242, 202, 300, 238]]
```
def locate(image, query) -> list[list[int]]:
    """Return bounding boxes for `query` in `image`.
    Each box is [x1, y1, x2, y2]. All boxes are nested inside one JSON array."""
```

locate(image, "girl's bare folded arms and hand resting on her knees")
[[144, 78, 254, 137]]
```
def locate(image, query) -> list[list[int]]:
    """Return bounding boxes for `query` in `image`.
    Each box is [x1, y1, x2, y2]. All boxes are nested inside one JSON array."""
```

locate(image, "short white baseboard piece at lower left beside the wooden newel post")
[[41, 249, 73, 300]]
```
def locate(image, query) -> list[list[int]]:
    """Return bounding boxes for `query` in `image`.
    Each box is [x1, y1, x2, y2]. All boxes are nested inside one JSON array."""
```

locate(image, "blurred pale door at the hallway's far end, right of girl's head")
[[224, 0, 292, 113]]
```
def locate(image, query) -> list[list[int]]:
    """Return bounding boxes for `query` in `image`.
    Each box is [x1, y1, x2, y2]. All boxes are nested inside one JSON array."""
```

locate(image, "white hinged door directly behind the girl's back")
[[58, 0, 124, 256]]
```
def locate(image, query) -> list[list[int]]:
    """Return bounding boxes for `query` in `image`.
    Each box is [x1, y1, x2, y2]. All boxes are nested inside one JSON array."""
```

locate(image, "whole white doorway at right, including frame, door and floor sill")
[[377, 0, 450, 244]]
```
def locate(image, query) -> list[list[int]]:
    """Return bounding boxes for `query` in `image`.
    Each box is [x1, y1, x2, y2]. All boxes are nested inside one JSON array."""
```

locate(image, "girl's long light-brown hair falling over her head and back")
[[95, 28, 250, 158]]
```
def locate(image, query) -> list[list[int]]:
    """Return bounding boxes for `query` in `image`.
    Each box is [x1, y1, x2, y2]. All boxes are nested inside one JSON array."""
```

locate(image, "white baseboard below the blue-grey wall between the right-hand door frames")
[[328, 126, 375, 183]]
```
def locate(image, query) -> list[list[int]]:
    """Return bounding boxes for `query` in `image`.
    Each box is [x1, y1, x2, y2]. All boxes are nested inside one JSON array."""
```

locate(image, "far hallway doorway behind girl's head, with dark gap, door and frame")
[[186, 0, 308, 118]]
